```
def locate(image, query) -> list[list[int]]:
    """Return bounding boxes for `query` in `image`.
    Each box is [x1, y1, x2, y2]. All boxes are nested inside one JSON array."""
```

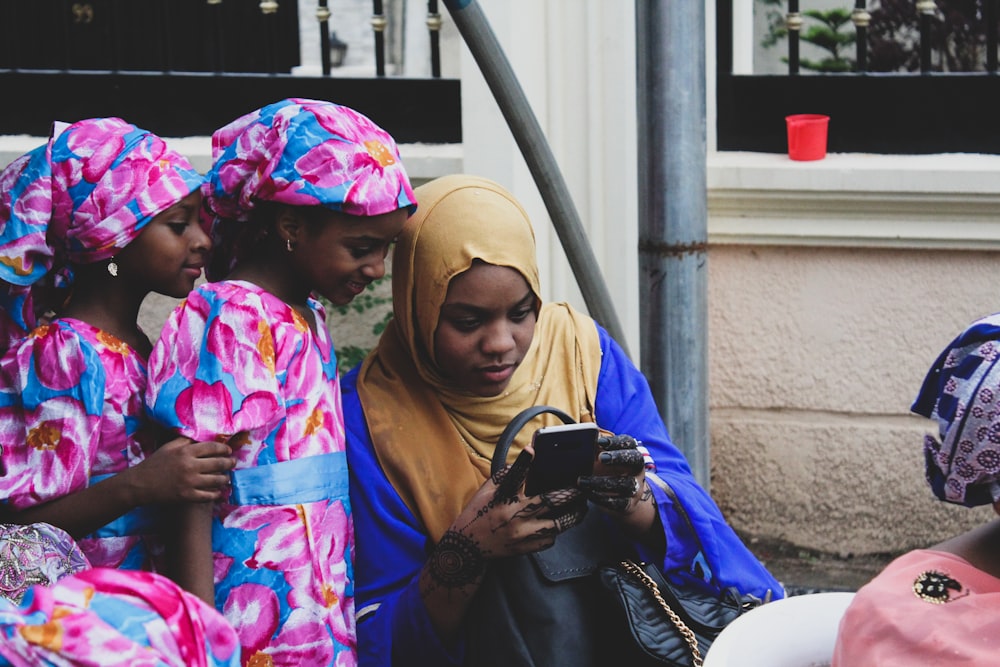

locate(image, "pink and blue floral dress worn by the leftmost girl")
[[0, 318, 162, 569]]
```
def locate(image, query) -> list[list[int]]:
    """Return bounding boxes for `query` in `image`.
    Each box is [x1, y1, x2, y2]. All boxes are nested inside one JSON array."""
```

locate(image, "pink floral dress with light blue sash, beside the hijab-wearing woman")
[[146, 281, 356, 667]]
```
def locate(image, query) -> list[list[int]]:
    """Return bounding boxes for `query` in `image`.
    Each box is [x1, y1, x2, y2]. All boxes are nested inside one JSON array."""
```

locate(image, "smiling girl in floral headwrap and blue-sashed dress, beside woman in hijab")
[[147, 99, 415, 667]]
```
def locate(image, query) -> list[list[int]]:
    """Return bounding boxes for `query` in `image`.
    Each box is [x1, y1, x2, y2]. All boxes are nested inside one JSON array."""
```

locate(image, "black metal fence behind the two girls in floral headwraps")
[[0, 0, 461, 143]]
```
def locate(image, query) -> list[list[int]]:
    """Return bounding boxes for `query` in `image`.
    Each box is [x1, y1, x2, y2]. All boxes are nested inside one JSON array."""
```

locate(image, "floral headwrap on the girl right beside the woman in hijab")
[[203, 98, 417, 280]]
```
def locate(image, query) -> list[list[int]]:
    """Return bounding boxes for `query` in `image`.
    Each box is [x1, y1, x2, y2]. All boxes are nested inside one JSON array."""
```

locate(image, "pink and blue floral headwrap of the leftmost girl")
[[0, 118, 204, 346]]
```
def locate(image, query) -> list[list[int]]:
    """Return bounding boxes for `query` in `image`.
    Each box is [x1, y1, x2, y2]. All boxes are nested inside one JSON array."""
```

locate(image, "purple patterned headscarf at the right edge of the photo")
[[910, 313, 1000, 507]]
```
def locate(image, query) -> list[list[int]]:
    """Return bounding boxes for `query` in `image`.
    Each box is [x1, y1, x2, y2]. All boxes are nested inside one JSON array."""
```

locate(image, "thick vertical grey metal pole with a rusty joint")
[[635, 0, 710, 489]]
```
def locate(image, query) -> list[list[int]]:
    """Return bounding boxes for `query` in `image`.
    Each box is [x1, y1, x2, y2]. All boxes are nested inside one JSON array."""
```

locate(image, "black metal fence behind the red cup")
[[716, 0, 1000, 154]]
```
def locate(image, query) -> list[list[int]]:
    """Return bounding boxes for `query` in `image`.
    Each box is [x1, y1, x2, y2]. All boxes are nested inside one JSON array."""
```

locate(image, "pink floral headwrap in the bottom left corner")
[[0, 568, 240, 667]]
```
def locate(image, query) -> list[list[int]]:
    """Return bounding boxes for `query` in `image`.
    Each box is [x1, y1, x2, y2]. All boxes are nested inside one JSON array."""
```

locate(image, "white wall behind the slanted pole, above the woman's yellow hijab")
[[461, 0, 639, 356]]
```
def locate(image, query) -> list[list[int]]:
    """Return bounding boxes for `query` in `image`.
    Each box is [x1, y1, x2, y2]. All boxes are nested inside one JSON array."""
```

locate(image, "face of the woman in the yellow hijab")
[[434, 262, 536, 396]]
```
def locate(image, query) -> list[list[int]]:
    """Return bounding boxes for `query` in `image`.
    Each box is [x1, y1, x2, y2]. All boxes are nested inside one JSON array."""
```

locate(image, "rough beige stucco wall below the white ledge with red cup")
[[709, 245, 1000, 553]]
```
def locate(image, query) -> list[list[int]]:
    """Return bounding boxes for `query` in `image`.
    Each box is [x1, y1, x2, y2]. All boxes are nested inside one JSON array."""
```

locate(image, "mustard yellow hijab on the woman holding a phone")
[[358, 175, 601, 541]]
